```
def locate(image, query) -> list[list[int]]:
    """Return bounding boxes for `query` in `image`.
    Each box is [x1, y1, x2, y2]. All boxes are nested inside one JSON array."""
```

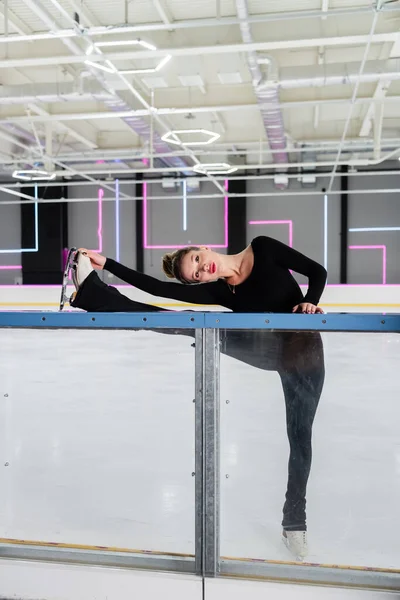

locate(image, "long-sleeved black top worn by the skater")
[[104, 236, 327, 313]]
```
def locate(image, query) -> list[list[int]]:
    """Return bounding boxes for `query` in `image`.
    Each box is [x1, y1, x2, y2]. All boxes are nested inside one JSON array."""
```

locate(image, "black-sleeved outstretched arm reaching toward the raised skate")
[[103, 258, 225, 304]]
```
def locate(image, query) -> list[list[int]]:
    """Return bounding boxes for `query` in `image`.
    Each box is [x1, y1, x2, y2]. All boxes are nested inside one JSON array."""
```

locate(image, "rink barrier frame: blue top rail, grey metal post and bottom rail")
[[0, 312, 400, 591]]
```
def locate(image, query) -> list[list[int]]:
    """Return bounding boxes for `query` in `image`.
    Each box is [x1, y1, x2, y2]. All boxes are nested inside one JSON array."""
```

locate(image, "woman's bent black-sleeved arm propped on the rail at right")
[[265, 237, 327, 306]]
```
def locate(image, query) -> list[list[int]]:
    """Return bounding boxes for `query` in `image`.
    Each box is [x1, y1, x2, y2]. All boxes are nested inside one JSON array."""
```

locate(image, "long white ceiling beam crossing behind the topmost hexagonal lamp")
[[0, 32, 398, 69]]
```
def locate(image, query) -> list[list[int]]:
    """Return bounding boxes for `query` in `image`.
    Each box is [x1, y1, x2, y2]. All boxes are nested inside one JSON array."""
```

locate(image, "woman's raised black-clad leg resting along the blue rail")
[[71, 271, 166, 312]]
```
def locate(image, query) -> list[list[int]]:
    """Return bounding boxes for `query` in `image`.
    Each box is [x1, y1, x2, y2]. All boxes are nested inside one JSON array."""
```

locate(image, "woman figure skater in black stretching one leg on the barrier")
[[71, 236, 327, 560]]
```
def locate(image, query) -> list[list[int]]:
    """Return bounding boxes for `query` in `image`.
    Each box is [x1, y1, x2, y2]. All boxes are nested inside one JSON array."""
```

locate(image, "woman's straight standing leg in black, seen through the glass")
[[279, 332, 325, 531]]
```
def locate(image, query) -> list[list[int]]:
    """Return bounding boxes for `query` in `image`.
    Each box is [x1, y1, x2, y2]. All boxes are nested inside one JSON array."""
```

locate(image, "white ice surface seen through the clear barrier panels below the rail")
[[0, 329, 400, 568]]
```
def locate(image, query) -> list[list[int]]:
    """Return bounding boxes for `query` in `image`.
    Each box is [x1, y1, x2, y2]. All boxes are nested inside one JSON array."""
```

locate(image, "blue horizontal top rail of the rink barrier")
[[0, 311, 400, 332]]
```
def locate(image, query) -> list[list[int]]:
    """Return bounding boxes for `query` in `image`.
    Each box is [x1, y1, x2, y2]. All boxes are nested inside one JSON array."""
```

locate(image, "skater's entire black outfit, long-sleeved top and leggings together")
[[71, 236, 326, 531]]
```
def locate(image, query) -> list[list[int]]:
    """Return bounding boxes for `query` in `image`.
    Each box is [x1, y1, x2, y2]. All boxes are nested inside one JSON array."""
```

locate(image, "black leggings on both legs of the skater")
[[71, 272, 325, 531]]
